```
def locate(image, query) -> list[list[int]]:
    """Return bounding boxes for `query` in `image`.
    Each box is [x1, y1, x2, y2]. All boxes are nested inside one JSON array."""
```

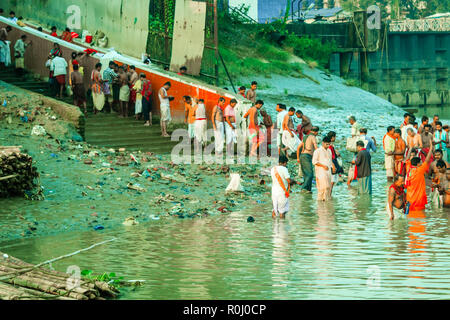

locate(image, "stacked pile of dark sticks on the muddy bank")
[[0, 146, 39, 198]]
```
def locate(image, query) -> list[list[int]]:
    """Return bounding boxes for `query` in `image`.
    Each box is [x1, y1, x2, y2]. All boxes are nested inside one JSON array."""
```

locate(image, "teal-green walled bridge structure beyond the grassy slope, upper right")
[[289, 11, 450, 115]]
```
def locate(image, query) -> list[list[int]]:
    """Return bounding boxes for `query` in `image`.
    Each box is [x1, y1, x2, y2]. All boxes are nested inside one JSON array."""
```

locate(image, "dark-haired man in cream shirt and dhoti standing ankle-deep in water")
[[312, 136, 336, 201]]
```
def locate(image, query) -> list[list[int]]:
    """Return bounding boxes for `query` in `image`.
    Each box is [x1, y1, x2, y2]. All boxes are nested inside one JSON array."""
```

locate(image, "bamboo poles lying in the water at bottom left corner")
[[0, 252, 119, 300]]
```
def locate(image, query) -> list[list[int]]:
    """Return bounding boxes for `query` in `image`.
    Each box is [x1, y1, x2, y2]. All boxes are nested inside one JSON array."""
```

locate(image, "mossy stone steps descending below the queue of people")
[[0, 67, 178, 154]]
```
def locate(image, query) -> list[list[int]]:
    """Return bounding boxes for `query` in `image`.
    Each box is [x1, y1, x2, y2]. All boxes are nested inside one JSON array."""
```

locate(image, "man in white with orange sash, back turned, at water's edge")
[[270, 156, 291, 219]]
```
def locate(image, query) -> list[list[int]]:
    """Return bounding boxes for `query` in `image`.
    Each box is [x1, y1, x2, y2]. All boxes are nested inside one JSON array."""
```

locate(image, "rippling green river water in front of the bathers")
[[0, 171, 450, 299]]
